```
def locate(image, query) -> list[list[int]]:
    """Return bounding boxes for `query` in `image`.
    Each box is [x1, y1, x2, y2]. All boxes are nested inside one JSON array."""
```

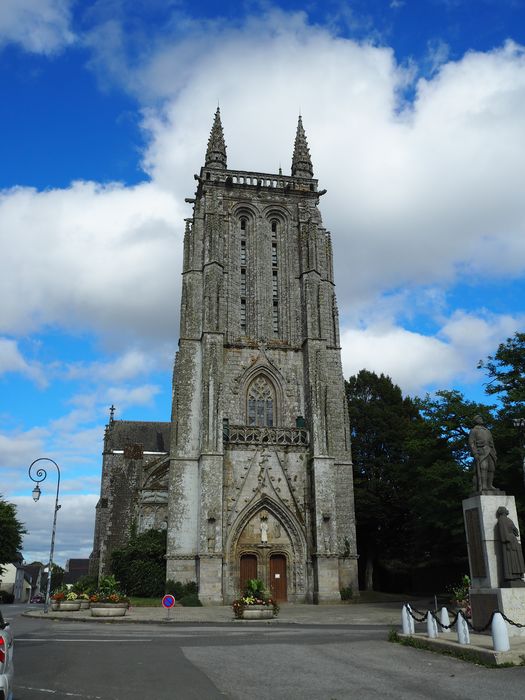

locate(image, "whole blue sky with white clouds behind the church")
[[0, 0, 525, 563]]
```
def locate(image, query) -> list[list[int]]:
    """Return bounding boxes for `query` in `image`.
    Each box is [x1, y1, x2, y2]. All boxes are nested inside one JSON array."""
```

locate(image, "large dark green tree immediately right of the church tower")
[[347, 370, 469, 589]]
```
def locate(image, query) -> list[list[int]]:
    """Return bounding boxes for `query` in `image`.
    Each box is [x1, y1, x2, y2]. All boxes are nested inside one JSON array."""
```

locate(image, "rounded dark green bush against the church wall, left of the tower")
[[111, 529, 166, 598]]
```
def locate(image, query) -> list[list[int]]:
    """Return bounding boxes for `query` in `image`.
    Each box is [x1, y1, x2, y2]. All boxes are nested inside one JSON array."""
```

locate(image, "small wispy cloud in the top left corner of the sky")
[[0, 0, 75, 54]]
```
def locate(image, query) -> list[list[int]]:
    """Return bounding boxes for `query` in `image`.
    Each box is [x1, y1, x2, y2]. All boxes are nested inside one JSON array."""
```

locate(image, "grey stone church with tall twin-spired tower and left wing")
[[92, 109, 358, 604]]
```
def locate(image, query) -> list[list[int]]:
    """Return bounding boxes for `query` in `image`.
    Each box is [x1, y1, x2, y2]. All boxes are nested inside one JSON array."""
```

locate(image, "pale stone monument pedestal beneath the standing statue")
[[463, 495, 525, 636]]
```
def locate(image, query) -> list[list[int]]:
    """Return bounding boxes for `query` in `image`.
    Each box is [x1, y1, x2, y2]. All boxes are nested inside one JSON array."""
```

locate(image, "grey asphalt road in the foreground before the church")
[[2, 606, 525, 700]]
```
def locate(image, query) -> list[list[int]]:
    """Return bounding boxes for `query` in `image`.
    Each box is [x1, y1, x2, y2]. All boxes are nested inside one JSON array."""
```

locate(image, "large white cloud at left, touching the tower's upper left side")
[[0, 182, 183, 346]]
